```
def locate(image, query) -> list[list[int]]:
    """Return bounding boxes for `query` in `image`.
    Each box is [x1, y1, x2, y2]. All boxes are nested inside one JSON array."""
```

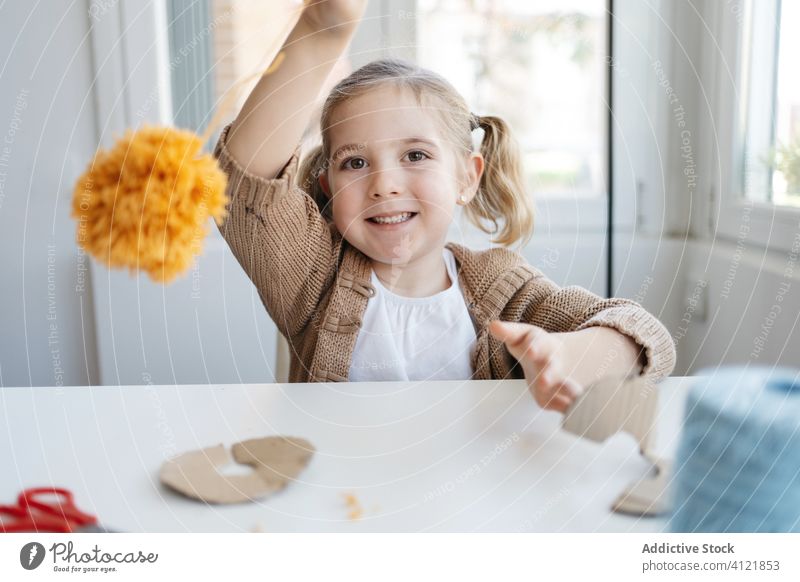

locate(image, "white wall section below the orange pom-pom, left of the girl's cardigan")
[[88, 233, 277, 385]]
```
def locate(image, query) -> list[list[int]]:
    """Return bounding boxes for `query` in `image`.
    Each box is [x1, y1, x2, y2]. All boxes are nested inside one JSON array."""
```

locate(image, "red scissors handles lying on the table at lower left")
[[0, 487, 97, 533]]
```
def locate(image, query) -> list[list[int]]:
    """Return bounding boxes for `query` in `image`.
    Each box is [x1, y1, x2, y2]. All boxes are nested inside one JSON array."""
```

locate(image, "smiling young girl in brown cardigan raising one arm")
[[215, 0, 675, 418]]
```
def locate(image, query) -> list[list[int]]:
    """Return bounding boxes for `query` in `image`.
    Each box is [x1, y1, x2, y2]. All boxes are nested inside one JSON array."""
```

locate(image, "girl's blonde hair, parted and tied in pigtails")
[[298, 59, 534, 246]]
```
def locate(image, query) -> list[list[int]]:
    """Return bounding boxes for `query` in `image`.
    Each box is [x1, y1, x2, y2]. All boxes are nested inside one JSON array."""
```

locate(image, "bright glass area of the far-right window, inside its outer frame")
[[740, 0, 800, 207]]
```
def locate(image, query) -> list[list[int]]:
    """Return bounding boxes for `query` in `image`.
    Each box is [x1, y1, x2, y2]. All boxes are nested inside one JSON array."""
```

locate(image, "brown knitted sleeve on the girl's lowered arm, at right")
[[521, 276, 675, 381]]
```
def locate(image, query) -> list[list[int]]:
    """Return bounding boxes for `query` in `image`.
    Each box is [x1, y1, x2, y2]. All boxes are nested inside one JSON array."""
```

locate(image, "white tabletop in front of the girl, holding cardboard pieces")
[[0, 378, 692, 532]]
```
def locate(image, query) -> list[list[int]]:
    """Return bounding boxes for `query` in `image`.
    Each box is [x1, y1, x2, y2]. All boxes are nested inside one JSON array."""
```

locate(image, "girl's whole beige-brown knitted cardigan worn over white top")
[[214, 127, 675, 382]]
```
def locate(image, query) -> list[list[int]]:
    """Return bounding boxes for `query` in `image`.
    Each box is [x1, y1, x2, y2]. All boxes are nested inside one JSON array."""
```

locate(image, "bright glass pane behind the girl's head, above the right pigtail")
[[417, 0, 607, 198]]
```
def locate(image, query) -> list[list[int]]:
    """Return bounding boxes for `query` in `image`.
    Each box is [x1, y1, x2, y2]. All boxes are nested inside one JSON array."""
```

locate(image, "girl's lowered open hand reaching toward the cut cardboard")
[[489, 320, 583, 413]]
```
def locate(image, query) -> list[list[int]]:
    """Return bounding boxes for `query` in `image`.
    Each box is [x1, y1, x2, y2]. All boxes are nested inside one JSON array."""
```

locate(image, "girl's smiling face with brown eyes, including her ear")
[[320, 84, 483, 265]]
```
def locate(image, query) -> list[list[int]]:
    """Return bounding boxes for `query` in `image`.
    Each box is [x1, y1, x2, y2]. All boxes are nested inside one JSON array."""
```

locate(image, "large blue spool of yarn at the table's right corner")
[[669, 366, 800, 532]]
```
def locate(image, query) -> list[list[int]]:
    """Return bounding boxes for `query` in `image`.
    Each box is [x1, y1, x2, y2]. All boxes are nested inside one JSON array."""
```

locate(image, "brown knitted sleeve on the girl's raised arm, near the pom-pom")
[[214, 126, 335, 337]]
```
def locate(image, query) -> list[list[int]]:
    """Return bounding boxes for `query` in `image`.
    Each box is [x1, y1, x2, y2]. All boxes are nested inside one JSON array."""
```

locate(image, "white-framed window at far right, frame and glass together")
[[704, 0, 800, 253]]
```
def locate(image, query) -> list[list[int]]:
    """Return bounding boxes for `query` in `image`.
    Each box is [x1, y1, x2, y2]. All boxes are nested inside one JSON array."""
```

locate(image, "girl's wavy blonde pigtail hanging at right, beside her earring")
[[465, 115, 534, 246]]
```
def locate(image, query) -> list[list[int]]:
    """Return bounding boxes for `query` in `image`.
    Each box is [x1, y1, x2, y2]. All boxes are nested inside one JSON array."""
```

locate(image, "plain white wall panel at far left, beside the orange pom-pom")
[[0, 0, 98, 386]]
